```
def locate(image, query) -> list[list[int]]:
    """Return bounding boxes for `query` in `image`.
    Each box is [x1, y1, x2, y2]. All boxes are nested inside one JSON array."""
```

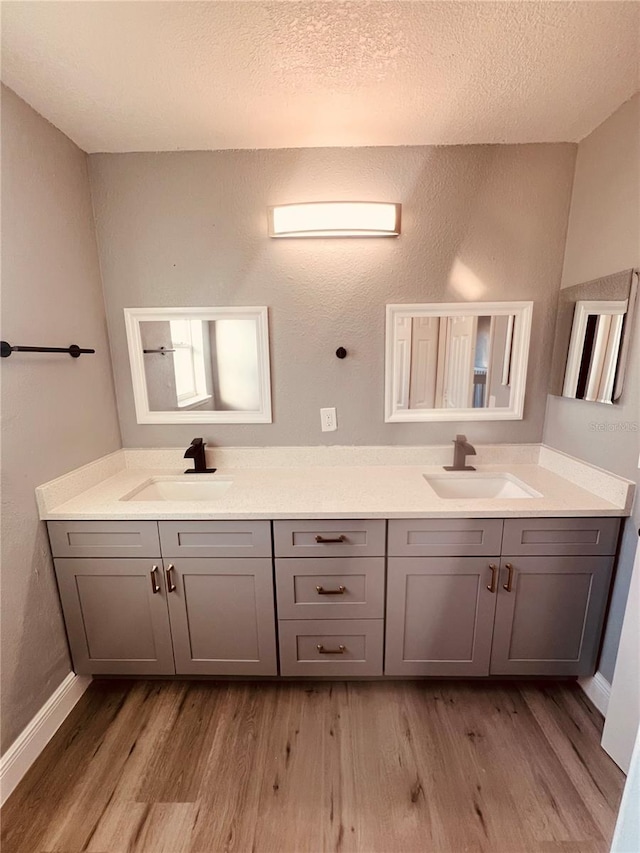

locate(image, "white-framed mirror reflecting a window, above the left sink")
[[124, 307, 271, 424]]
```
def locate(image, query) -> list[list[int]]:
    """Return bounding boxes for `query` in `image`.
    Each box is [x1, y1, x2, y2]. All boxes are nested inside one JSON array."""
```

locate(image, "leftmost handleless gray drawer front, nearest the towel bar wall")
[[47, 521, 160, 557]]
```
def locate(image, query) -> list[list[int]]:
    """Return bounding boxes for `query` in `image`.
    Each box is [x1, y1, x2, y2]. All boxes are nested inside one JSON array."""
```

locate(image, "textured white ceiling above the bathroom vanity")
[[2, 0, 640, 152]]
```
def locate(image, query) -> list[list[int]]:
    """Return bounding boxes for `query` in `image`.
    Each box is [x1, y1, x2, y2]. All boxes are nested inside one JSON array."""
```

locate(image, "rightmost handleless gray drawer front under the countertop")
[[502, 518, 620, 557]]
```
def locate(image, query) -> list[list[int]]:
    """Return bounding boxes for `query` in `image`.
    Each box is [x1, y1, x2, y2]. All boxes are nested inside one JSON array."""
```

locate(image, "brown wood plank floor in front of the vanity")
[[2, 681, 624, 853]]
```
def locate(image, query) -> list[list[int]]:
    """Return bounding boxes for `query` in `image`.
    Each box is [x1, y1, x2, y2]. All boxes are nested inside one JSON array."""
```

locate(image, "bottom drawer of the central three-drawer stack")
[[279, 619, 384, 676]]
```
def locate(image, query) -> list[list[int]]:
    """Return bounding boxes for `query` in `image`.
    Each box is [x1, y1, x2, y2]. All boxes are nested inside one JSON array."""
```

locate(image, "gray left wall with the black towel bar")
[[1, 88, 120, 752]]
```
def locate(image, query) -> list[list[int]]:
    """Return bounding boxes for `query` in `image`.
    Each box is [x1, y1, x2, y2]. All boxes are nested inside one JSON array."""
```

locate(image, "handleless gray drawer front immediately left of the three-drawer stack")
[[160, 521, 271, 557]]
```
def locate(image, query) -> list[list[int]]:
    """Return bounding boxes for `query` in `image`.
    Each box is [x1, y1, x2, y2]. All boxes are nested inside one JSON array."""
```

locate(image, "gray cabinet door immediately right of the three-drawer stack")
[[385, 557, 500, 676]]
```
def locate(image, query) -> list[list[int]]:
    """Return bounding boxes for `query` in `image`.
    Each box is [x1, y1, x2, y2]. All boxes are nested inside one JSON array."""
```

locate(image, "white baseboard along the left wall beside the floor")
[[0, 672, 92, 806]]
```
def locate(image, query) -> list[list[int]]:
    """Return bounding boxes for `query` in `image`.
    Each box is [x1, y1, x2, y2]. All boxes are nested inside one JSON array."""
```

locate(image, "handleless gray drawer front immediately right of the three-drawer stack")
[[389, 518, 502, 557]]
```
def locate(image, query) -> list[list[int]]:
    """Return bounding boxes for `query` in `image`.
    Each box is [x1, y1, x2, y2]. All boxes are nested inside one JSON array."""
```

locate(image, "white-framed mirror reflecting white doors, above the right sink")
[[385, 302, 533, 423]]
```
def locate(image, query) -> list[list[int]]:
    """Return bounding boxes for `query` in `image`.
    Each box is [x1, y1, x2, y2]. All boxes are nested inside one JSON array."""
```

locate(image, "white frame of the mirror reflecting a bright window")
[[124, 306, 272, 424]]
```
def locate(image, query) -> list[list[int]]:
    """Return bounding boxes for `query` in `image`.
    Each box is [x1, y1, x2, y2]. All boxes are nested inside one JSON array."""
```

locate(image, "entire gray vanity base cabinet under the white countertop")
[[49, 517, 620, 678]]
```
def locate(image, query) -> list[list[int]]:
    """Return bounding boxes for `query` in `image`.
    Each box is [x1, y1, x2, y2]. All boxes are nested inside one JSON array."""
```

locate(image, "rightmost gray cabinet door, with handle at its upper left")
[[491, 556, 614, 676]]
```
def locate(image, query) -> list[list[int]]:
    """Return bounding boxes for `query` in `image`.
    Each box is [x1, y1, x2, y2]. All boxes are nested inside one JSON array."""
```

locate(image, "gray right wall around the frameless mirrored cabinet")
[[544, 95, 640, 681]]
